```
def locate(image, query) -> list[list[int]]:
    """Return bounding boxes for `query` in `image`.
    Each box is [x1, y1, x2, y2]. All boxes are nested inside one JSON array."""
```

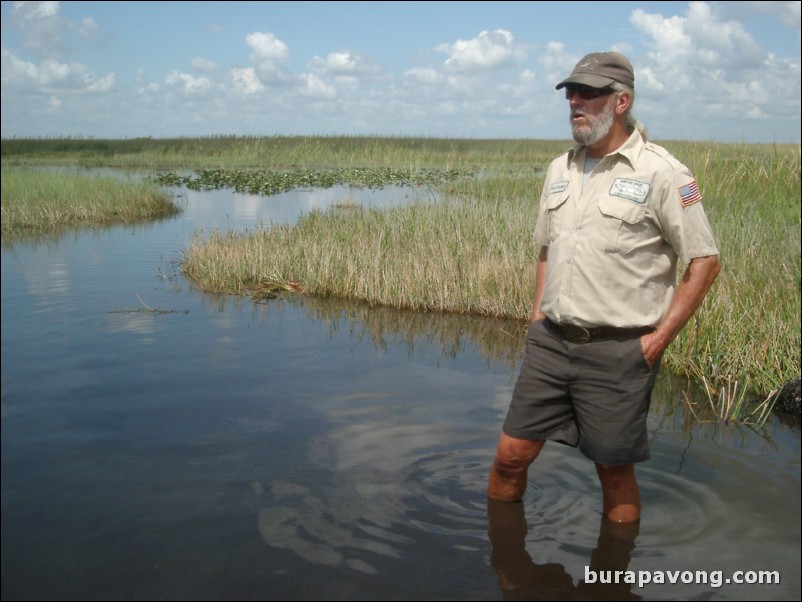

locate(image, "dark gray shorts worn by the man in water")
[[503, 320, 659, 465]]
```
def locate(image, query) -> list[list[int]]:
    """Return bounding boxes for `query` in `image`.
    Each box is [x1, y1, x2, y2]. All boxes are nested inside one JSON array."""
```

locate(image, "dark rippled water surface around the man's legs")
[[2, 180, 800, 600]]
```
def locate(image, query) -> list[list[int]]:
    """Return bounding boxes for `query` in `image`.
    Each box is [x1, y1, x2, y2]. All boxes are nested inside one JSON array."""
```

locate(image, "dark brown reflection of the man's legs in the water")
[[487, 499, 642, 600]]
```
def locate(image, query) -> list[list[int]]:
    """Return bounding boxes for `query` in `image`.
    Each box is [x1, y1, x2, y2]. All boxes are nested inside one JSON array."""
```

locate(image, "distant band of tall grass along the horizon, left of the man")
[[0, 136, 568, 171]]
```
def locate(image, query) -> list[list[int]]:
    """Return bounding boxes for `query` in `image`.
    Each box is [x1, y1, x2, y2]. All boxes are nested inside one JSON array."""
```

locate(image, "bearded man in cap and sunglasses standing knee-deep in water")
[[488, 52, 720, 523]]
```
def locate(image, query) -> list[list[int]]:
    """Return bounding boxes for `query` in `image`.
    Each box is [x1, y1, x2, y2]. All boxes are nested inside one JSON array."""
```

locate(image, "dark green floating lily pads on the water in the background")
[[154, 167, 473, 195]]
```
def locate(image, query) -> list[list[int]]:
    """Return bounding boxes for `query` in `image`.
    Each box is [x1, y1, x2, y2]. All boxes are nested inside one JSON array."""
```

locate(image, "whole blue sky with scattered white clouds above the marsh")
[[0, 0, 802, 144]]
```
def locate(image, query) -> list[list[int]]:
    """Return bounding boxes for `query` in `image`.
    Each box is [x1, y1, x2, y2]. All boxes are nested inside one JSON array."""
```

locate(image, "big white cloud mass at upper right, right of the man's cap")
[[631, 2, 800, 135]]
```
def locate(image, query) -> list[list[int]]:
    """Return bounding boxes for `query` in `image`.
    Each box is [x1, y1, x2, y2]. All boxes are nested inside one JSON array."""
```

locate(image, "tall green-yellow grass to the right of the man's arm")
[[668, 145, 802, 406]]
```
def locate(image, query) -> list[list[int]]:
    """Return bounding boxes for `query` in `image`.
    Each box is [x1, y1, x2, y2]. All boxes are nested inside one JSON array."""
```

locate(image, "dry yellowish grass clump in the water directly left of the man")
[[183, 173, 537, 317]]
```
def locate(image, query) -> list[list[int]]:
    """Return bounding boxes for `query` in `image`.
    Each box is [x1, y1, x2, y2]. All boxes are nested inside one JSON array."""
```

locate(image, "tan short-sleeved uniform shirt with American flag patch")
[[535, 130, 718, 327]]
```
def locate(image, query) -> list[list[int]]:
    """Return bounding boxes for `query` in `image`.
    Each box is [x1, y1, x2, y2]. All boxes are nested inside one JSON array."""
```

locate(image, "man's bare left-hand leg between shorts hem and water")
[[487, 433, 545, 502]]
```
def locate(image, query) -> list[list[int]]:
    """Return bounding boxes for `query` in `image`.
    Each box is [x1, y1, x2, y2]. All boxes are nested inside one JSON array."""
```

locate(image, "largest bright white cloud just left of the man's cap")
[[435, 29, 525, 71]]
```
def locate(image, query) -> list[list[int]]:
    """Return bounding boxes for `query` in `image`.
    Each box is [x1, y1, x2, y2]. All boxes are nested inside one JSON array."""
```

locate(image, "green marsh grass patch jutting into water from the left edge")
[[2, 168, 180, 238]]
